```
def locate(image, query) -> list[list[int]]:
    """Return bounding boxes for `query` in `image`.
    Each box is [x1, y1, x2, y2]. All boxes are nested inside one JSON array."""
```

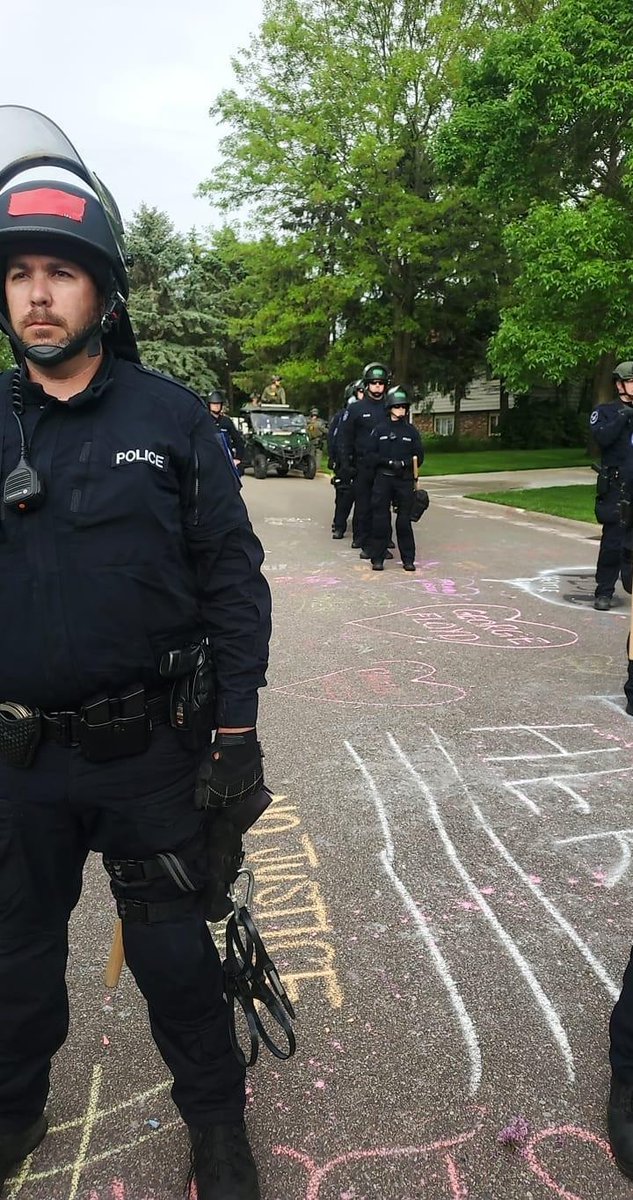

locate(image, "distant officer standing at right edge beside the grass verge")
[[590, 362, 633, 612]]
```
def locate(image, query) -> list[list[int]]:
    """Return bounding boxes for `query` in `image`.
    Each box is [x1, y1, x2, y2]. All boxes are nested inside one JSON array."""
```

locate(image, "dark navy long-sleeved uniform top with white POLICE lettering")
[[0, 358, 270, 727]]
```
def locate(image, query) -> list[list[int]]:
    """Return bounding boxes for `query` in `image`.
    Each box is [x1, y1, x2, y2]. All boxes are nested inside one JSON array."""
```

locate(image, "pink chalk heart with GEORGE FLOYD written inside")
[[349, 604, 578, 650]]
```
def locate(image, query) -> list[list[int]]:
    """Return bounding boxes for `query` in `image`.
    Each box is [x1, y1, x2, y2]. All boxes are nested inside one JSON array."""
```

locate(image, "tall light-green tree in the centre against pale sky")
[[201, 0, 501, 412]]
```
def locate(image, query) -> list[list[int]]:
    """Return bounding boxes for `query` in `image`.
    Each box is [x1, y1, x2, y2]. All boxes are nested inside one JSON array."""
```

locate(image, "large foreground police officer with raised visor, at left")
[[0, 107, 270, 1200]]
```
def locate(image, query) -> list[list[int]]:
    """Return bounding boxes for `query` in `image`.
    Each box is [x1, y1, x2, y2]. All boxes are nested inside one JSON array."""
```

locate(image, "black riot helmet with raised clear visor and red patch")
[[0, 104, 139, 366]]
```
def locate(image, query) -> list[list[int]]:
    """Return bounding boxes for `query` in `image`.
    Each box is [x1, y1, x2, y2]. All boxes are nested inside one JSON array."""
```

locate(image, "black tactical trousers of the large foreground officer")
[[0, 726, 245, 1133]]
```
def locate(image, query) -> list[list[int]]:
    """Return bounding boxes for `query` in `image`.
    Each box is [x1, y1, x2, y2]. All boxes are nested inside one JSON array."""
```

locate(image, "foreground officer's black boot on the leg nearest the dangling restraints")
[[188, 1121, 261, 1200]]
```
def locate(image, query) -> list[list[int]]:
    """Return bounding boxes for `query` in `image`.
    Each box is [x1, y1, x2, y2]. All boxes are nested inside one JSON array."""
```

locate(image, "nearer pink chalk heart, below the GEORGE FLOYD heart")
[[272, 659, 466, 708]]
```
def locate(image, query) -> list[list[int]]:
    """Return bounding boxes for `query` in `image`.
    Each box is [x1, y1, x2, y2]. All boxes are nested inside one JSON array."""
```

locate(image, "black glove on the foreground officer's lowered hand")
[[194, 730, 264, 809]]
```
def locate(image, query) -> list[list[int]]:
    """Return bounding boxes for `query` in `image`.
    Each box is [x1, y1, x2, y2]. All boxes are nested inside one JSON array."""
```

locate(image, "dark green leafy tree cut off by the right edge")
[[438, 0, 633, 398]]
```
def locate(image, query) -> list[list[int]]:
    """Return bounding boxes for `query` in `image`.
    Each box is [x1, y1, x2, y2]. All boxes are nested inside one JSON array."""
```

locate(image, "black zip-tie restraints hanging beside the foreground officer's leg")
[[222, 868, 296, 1067]]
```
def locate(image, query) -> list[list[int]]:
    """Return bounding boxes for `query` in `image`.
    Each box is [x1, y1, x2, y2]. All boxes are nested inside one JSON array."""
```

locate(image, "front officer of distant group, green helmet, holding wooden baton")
[[368, 386, 424, 571]]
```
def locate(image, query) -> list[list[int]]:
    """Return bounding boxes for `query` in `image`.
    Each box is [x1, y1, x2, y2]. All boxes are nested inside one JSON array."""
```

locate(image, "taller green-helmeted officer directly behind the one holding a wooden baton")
[[338, 362, 393, 558]]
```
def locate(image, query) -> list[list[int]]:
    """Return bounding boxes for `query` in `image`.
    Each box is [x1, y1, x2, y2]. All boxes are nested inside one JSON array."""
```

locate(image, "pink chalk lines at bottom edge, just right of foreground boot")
[[272, 1126, 481, 1200]]
